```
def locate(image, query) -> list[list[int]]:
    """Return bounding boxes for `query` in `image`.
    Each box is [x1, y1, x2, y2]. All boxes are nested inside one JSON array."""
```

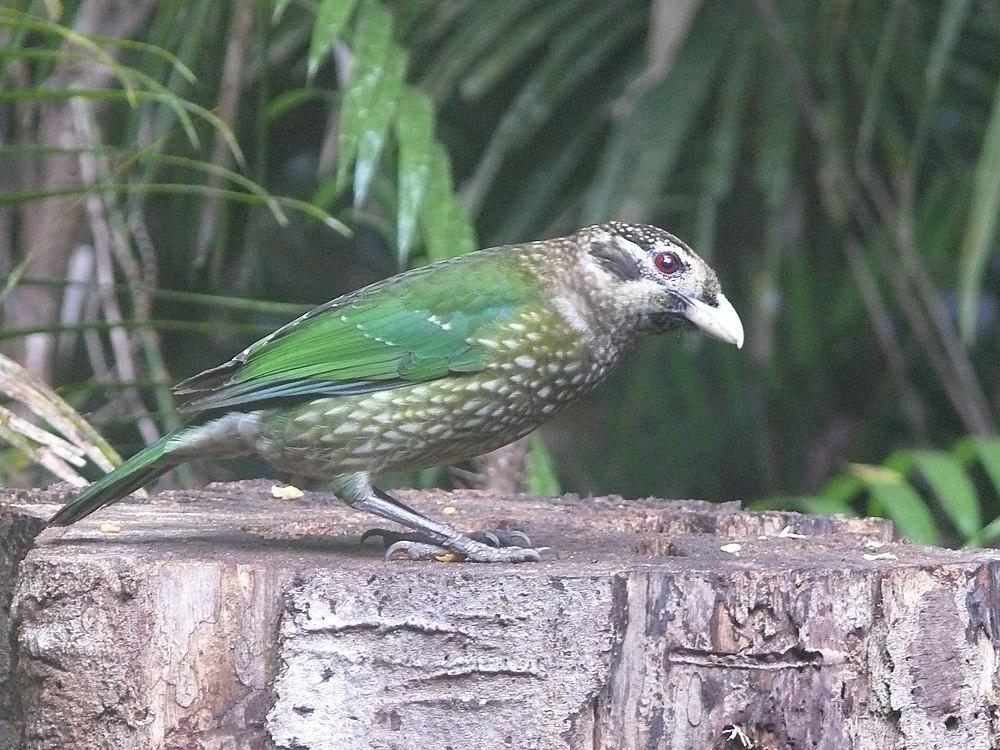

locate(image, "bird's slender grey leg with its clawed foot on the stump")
[[351, 487, 540, 562]]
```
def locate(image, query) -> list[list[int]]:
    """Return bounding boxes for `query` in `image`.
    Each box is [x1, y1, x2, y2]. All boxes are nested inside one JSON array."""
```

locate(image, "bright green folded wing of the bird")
[[176, 253, 543, 418]]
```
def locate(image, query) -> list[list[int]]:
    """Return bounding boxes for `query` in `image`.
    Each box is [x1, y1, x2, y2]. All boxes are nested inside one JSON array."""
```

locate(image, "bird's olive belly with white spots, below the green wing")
[[250, 355, 607, 476]]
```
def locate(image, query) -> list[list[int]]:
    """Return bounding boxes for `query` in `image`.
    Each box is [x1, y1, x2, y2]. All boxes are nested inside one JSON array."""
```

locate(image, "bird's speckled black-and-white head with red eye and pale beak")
[[580, 221, 743, 347]]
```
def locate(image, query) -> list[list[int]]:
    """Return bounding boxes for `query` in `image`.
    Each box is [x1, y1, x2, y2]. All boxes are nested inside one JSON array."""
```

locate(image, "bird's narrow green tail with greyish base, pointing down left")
[[49, 412, 257, 526]]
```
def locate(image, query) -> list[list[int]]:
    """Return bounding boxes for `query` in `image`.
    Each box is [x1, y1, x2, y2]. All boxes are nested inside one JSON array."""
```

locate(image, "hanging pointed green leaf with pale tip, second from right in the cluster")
[[396, 87, 434, 268]]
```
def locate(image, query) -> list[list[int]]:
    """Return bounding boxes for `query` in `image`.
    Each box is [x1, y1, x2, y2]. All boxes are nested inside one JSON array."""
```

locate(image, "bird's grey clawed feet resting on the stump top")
[[361, 529, 544, 563]]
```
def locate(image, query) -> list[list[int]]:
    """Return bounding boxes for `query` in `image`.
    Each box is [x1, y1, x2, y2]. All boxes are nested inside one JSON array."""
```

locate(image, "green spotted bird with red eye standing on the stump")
[[49, 221, 744, 563]]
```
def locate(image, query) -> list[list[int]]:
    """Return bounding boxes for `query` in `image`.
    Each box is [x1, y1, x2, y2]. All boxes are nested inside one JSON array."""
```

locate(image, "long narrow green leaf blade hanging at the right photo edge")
[[958, 74, 1000, 342]]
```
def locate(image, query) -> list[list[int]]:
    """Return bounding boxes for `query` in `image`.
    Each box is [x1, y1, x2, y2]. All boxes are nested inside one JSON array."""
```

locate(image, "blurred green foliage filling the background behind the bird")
[[0, 0, 1000, 543]]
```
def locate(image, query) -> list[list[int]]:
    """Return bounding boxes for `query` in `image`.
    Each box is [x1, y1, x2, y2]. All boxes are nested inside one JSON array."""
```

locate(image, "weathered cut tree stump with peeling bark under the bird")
[[0, 481, 1000, 750]]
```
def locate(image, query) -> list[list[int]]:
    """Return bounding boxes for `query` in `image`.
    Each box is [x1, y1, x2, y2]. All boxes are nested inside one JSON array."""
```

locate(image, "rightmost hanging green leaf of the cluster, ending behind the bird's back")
[[420, 143, 476, 262]]
